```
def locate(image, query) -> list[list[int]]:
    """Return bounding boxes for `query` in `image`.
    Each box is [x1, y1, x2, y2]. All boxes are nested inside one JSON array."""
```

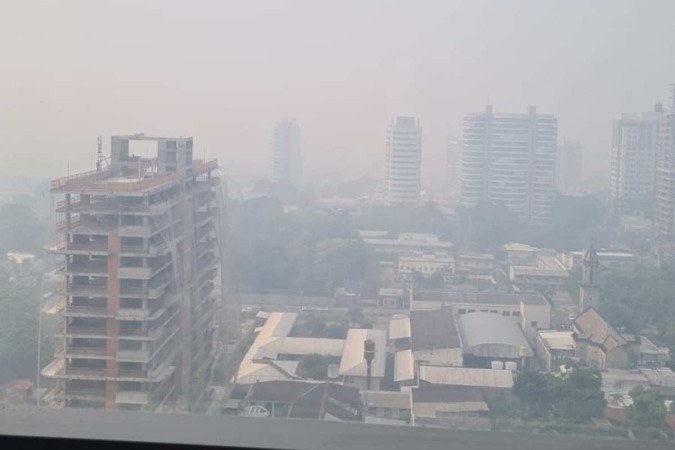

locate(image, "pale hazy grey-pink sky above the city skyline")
[[0, 0, 675, 190]]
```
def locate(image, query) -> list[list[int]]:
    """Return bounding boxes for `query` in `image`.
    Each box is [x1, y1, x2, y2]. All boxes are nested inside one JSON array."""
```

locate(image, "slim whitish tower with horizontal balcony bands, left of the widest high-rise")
[[384, 116, 422, 205]]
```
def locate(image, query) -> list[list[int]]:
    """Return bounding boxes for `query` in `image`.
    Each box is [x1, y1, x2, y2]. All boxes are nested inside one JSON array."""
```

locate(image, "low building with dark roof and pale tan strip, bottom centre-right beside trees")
[[411, 386, 490, 430]]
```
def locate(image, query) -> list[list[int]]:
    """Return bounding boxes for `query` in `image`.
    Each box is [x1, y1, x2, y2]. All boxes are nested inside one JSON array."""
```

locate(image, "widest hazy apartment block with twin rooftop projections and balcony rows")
[[461, 105, 558, 225]]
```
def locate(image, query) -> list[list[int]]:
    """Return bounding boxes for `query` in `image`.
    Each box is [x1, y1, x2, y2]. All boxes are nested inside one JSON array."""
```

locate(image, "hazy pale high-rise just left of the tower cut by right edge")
[[609, 111, 660, 213]]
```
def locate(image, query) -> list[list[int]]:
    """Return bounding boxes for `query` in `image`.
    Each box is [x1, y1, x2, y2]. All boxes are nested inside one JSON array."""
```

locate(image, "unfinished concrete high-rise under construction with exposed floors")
[[42, 134, 223, 411]]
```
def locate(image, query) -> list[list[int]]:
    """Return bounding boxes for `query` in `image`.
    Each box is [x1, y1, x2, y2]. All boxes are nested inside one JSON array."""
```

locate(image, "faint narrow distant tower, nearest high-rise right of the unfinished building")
[[272, 119, 302, 187]]
